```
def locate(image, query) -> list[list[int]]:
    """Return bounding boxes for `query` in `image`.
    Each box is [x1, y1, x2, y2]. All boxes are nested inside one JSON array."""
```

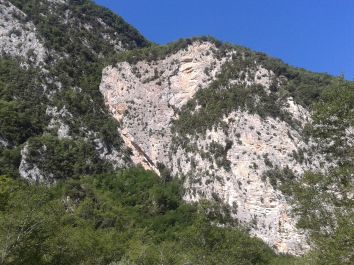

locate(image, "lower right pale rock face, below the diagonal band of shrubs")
[[171, 111, 320, 254]]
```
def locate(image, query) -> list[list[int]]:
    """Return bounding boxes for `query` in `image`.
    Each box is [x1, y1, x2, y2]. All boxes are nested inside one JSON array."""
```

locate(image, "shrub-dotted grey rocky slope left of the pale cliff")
[[0, 0, 149, 183]]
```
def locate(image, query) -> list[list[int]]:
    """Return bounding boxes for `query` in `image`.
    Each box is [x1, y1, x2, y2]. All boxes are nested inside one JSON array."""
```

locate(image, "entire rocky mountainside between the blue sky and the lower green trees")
[[0, 0, 354, 255]]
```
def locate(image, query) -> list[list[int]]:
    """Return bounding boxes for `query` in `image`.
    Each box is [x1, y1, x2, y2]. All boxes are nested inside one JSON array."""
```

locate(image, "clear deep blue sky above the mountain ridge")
[[95, 0, 354, 80]]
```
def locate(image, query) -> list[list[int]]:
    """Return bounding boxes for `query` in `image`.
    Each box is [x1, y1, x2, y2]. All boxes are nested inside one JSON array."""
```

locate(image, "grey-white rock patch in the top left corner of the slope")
[[0, 0, 46, 65]]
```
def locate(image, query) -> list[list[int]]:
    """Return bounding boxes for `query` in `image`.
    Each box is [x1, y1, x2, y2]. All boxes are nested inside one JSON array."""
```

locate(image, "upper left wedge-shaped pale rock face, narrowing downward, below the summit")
[[100, 42, 230, 171]]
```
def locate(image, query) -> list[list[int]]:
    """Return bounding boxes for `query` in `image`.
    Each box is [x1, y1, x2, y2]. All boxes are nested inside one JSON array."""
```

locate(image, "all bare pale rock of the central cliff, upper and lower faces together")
[[100, 42, 323, 255]]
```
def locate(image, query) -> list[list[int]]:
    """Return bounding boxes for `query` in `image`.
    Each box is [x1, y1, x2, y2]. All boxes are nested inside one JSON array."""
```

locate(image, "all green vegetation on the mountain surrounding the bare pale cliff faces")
[[0, 0, 354, 265]]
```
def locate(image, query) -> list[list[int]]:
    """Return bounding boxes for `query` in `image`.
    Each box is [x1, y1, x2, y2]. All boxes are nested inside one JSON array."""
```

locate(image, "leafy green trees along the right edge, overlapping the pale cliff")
[[265, 79, 354, 265]]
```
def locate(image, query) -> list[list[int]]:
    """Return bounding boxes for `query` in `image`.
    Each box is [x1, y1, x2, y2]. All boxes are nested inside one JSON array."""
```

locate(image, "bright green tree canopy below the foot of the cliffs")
[[0, 168, 291, 265]]
